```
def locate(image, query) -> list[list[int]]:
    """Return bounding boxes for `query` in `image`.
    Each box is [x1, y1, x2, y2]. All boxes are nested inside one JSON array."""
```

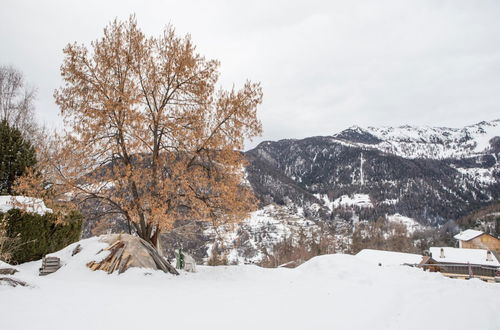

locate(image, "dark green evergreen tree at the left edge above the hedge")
[[0, 120, 36, 195]]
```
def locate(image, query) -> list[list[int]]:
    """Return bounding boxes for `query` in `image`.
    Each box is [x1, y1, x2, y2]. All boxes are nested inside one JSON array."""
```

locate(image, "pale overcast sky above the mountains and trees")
[[0, 0, 500, 146]]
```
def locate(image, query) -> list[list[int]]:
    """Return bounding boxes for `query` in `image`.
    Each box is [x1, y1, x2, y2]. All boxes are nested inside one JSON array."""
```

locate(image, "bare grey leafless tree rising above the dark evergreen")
[[0, 66, 38, 138]]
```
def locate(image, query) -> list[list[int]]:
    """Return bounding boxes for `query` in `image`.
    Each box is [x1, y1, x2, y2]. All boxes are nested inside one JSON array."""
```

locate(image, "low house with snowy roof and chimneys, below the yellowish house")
[[419, 247, 500, 282]]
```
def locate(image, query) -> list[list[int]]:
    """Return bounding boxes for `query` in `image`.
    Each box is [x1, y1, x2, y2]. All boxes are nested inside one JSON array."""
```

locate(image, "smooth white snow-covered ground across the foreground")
[[0, 238, 500, 330]]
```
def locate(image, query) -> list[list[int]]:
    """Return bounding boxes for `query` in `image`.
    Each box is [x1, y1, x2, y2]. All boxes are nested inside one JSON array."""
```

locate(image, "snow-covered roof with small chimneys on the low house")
[[430, 247, 500, 267]]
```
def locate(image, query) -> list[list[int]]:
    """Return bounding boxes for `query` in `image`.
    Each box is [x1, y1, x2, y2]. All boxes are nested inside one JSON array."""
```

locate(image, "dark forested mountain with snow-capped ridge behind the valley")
[[247, 120, 500, 225]]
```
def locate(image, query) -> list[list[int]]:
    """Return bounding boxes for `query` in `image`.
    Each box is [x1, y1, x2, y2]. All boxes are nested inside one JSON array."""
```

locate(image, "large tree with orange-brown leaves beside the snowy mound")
[[18, 16, 262, 245]]
